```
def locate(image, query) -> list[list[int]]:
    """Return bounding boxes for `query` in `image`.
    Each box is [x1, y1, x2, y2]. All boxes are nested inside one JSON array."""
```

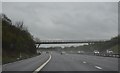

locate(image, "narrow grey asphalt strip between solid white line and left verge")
[[2, 53, 49, 71]]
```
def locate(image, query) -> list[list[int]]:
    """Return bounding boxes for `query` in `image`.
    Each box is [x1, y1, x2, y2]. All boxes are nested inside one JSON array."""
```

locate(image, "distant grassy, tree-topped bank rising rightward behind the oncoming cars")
[[39, 36, 120, 54]]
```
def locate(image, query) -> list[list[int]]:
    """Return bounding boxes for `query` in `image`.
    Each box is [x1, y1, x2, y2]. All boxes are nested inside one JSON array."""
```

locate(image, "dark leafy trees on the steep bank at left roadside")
[[1, 14, 36, 63]]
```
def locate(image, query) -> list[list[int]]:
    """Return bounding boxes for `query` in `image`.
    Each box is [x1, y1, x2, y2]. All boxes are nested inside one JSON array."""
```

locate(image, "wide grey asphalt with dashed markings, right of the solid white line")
[[42, 52, 118, 71]]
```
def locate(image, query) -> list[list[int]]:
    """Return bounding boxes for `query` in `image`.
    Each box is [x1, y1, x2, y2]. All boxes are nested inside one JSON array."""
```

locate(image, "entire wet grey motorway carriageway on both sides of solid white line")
[[3, 52, 118, 71]]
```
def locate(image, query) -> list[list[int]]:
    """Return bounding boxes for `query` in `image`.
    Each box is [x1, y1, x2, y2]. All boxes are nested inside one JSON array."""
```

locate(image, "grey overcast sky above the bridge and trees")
[[2, 2, 118, 46]]
